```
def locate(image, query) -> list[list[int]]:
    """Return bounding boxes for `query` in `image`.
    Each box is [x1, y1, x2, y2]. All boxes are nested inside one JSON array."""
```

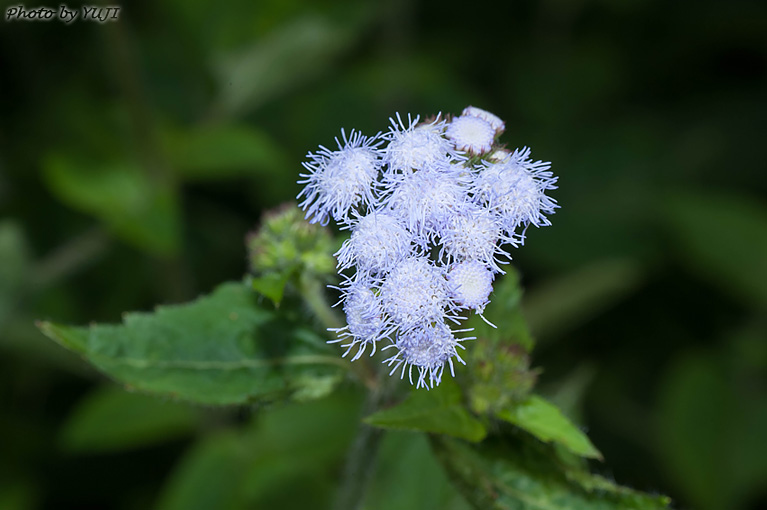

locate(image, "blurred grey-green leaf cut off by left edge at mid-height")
[[0, 220, 29, 328]]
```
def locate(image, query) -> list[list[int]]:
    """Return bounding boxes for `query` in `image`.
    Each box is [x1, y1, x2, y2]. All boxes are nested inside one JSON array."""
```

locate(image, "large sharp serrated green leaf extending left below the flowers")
[[39, 283, 346, 405]]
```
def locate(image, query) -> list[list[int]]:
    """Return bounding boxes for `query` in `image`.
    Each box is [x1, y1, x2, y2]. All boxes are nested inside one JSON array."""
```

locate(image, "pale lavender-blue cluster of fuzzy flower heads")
[[298, 106, 557, 388]]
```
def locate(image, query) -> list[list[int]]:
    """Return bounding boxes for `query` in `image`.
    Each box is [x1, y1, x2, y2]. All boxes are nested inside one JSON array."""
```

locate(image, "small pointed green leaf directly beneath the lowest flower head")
[[364, 379, 487, 441]]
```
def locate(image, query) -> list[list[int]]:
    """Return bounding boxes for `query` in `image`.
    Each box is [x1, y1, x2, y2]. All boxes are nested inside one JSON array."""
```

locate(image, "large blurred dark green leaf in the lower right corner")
[[658, 355, 767, 510]]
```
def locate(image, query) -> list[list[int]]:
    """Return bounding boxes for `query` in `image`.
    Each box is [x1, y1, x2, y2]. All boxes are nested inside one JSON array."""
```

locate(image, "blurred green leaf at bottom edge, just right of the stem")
[[363, 431, 471, 510]]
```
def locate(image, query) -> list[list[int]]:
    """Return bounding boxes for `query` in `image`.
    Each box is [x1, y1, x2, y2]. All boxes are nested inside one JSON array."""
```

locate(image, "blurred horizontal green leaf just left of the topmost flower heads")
[[163, 124, 288, 180]]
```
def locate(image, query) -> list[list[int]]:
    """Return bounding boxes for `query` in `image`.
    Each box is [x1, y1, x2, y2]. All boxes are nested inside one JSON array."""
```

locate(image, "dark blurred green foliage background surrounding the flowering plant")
[[0, 0, 767, 510]]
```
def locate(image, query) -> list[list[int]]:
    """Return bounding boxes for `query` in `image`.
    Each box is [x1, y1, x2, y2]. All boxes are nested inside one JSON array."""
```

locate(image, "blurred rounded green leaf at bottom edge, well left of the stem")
[[157, 432, 252, 510]]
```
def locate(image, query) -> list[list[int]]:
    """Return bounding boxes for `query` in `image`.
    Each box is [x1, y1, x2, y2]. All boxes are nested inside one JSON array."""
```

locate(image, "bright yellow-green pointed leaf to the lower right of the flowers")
[[495, 395, 602, 459]]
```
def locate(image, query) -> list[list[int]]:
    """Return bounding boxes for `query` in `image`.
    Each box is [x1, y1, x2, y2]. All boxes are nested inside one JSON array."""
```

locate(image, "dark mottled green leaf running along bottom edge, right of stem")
[[432, 436, 669, 510]]
